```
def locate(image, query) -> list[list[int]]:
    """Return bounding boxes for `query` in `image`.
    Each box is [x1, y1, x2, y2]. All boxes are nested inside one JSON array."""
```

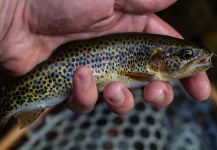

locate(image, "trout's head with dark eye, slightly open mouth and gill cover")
[[150, 44, 213, 81]]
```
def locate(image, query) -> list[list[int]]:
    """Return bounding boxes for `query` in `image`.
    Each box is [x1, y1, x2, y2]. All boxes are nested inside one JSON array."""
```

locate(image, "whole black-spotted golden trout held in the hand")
[[0, 33, 213, 129]]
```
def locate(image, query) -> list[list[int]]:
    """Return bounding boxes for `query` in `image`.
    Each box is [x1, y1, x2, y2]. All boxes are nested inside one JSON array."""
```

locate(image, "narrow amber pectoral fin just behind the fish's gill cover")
[[121, 71, 153, 82]]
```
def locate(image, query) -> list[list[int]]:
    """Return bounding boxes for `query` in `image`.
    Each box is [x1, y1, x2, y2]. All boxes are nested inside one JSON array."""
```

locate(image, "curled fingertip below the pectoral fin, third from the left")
[[143, 82, 174, 108]]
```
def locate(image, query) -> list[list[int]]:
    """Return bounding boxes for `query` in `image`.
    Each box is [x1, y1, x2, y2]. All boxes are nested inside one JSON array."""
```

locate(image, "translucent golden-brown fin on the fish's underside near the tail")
[[14, 110, 44, 129]]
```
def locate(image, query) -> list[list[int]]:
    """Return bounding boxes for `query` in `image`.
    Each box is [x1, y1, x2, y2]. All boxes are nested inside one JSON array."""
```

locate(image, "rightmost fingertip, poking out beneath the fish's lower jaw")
[[180, 72, 211, 101]]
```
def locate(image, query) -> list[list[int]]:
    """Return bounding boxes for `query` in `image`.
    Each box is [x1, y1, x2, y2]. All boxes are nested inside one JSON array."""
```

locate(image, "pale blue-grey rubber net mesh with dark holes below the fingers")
[[13, 82, 217, 150]]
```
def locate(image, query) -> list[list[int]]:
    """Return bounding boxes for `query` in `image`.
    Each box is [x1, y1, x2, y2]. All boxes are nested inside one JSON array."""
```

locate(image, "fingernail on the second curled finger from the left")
[[109, 87, 125, 105]]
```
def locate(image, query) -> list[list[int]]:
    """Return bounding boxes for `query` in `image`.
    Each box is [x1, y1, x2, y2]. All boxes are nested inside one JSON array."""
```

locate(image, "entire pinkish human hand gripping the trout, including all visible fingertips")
[[0, 0, 210, 114]]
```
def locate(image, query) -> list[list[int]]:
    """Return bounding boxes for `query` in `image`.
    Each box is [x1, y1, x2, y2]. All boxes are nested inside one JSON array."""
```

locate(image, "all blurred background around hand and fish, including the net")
[[0, 0, 217, 150]]
